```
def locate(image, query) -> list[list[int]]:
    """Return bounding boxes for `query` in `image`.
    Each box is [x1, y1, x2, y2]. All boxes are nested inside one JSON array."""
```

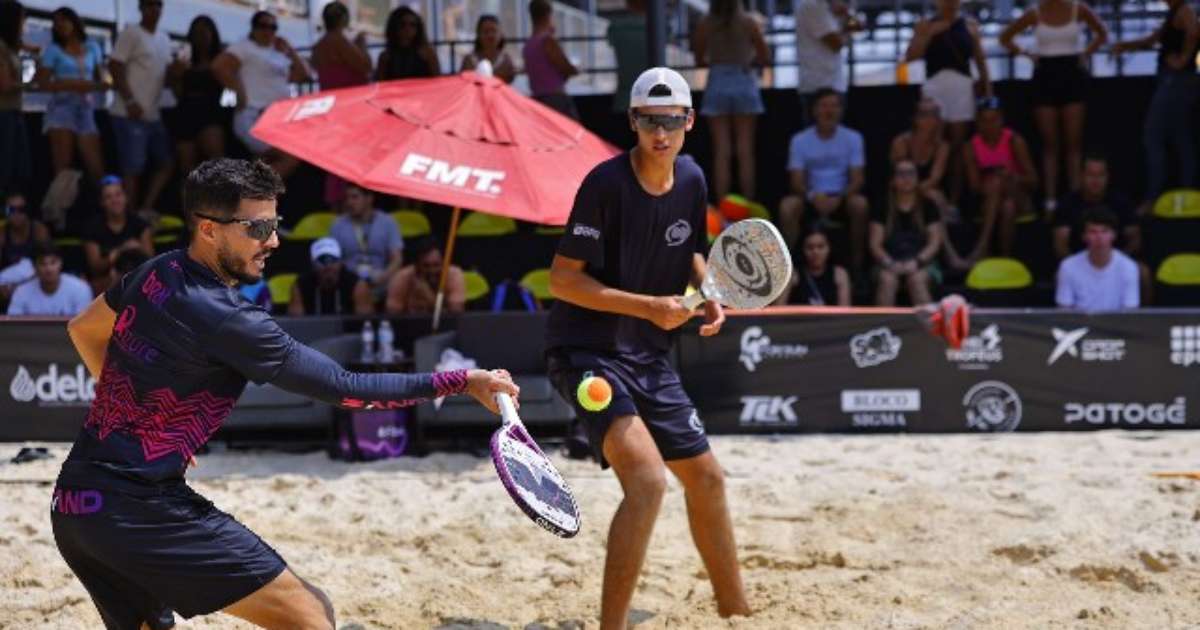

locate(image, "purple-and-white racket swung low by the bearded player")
[[492, 394, 580, 538]]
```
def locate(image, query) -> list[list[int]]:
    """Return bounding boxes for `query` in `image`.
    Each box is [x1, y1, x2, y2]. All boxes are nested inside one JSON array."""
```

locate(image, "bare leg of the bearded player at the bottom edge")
[[222, 569, 334, 630]]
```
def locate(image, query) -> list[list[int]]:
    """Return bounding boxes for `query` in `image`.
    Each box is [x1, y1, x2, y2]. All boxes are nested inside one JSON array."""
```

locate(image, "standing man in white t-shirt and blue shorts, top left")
[[108, 0, 174, 210]]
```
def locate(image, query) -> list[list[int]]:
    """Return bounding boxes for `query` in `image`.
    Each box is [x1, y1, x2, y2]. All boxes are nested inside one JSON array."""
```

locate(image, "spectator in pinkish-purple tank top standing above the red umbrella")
[[521, 0, 580, 120]]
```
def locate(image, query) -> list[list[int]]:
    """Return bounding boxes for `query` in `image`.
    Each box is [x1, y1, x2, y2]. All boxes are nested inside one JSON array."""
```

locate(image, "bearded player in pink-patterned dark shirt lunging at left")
[[50, 160, 517, 630]]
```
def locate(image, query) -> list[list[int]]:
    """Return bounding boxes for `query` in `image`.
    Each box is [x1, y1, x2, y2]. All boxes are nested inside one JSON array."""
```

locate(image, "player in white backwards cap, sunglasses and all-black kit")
[[546, 67, 750, 629]]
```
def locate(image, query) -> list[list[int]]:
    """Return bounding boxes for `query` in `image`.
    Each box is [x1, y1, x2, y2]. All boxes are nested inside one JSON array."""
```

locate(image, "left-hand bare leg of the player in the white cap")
[[600, 415, 667, 630]]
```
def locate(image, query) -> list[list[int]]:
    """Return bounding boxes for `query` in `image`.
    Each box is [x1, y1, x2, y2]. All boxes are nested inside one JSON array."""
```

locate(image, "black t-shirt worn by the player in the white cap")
[[546, 152, 708, 354]]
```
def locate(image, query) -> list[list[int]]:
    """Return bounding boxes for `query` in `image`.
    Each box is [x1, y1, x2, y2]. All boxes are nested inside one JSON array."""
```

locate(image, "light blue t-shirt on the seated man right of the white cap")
[[787, 125, 866, 194]]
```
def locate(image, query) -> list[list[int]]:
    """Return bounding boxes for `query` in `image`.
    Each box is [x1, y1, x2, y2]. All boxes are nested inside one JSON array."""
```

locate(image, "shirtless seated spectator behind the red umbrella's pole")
[[388, 236, 467, 314]]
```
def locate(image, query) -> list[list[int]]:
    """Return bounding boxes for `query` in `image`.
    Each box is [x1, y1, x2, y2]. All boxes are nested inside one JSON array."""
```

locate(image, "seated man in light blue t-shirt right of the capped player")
[[779, 89, 866, 271]]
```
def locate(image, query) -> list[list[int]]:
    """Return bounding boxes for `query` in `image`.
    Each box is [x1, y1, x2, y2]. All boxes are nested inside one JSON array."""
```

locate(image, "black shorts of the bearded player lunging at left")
[[50, 482, 287, 630]]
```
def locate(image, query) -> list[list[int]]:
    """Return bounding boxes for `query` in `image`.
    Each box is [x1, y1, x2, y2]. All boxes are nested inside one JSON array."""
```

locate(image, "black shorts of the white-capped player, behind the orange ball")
[[546, 348, 708, 468]]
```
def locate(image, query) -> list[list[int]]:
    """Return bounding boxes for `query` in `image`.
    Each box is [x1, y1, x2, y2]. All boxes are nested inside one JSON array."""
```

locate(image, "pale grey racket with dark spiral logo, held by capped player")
[[683, 218, 792, 308]]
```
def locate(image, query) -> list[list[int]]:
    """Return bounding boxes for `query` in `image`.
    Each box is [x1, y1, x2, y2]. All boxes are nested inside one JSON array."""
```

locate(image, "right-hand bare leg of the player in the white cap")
[[667, 451, 750, 617]]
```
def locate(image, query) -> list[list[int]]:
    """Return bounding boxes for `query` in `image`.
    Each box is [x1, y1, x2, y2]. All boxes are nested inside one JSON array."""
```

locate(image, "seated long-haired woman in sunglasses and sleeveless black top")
[[871, 160, 942, 306]]
